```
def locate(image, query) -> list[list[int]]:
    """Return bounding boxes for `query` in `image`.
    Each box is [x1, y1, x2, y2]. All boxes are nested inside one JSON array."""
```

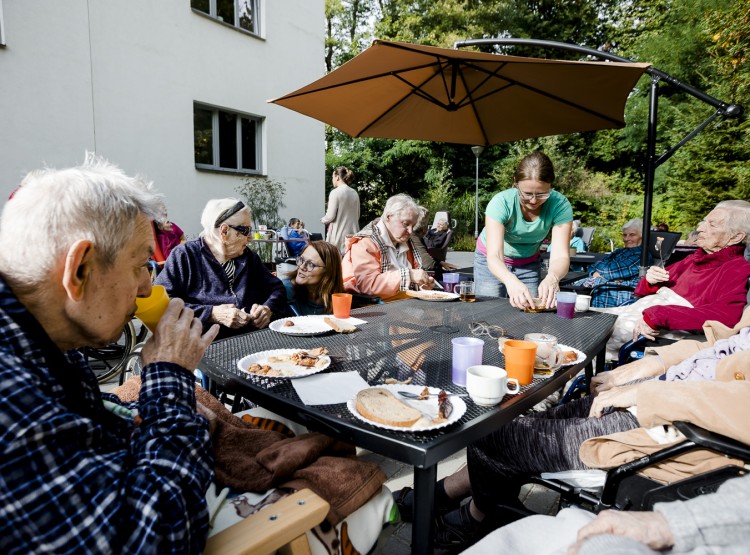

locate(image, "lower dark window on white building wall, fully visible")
[[193, 103, 263, 174]]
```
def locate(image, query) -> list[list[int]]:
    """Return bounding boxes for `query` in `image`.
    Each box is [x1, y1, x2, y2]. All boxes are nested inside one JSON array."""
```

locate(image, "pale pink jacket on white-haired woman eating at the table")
[[341, 226, 422, 299]]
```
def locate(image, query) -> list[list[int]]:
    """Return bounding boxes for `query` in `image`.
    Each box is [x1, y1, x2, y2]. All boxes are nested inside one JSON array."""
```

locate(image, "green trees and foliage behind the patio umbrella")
[[326, 0, 750, 250]]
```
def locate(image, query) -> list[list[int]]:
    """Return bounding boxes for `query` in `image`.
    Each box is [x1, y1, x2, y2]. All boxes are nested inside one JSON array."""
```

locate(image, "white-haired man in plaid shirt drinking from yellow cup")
[[0, 155, 218, 553]]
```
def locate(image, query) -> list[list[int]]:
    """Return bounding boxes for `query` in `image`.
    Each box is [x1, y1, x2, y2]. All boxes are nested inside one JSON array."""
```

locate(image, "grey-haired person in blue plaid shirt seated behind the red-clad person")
[[573, 219, 651, 308]]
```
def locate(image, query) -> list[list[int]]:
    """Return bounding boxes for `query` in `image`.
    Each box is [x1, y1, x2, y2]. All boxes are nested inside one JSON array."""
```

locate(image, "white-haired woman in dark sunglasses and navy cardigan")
[[155, 198, 287, 338]]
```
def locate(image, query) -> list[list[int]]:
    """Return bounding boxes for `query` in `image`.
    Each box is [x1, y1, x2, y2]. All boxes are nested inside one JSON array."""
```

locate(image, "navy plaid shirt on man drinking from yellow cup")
[[0, 279, 213, 554]]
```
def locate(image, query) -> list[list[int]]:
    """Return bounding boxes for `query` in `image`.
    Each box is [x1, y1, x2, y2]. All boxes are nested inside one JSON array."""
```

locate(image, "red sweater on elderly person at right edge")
[[635, 245, 750, 330]]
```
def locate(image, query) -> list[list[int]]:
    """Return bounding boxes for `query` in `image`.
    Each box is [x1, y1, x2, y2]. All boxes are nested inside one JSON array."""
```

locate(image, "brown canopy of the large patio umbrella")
[[269, 40, 649, 145]]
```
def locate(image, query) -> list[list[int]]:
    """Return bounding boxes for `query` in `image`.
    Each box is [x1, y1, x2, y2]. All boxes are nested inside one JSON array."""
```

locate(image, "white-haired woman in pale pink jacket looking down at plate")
[[342, 194, 434, 298]]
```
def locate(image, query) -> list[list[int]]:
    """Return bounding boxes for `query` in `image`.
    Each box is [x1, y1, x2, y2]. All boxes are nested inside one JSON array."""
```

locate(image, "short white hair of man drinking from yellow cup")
[[0, 152, 163, 288]]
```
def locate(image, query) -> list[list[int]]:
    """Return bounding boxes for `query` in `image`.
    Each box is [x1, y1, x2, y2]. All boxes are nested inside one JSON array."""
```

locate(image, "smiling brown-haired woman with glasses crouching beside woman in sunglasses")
[[282, 241, 344, 316]]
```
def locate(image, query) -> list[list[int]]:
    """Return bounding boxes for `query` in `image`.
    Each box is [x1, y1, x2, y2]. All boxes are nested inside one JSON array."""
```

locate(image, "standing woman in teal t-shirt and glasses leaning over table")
[[474, 151, 573, 308]]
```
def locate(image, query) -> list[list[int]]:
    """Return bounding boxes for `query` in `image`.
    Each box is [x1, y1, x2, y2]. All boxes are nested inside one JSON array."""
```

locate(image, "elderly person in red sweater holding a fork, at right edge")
[[601, 200, 750, 359]]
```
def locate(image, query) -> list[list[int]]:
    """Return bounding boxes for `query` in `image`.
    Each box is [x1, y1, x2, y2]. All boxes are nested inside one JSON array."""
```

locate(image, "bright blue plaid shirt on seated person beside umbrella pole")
[[573, 246, 650, 308]]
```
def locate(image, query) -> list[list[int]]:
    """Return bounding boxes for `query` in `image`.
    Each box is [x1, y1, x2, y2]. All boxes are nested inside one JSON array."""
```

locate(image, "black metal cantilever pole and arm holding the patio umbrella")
[[454, 38, 743, 273]]
